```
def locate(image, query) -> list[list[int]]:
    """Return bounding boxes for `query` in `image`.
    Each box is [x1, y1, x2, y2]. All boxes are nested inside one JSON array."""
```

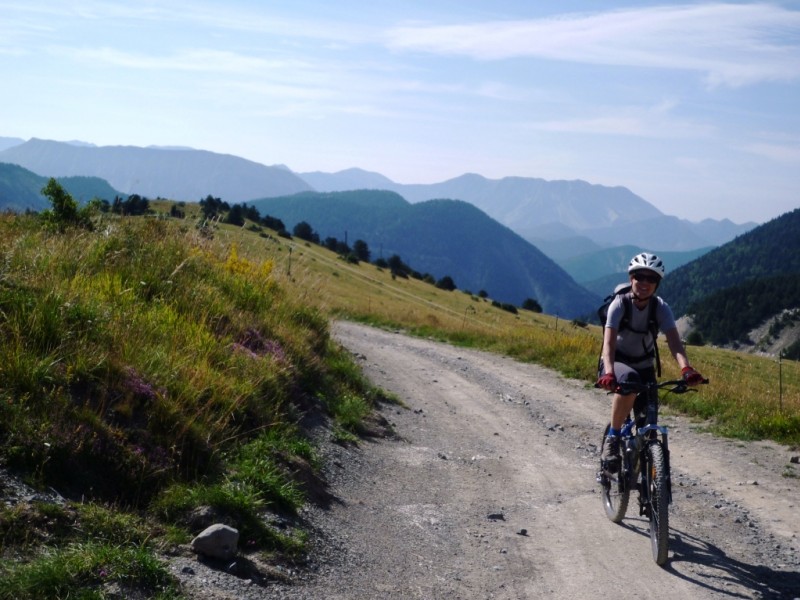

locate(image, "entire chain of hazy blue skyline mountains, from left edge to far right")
[[0, 138, 756, 254]]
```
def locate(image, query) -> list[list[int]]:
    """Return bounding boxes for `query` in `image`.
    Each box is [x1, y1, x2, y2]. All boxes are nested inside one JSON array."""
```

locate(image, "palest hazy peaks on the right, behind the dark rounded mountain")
[[300, 169, 756, 261]]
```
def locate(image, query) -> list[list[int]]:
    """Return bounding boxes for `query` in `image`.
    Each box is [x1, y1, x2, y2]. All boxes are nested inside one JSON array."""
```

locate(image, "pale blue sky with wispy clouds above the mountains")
[[0, 0, 800, 223]]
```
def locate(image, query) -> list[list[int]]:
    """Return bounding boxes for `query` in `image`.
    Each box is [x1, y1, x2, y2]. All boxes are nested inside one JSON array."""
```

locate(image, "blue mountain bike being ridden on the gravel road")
[[597, 379, 708, 565]]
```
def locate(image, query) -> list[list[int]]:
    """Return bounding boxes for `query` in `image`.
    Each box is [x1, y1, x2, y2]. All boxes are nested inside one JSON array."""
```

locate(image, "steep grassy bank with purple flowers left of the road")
[[0, 205, 378, 598]]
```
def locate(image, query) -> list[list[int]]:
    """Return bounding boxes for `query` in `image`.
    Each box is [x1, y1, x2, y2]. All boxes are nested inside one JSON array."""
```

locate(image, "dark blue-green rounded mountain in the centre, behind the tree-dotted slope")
[[250, 190, 600, 318]]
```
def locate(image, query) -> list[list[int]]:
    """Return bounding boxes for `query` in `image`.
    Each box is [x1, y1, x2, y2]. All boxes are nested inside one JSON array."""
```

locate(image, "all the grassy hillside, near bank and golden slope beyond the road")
[[0, 195, 800, 600]]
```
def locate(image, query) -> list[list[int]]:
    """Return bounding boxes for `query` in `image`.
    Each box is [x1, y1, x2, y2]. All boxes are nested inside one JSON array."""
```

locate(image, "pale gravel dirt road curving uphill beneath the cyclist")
[[181, 323, 800, 600]]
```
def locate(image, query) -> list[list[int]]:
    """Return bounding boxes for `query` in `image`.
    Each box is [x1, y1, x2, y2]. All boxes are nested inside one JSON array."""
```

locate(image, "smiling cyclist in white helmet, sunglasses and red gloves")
[[597, 252, 703, 473]]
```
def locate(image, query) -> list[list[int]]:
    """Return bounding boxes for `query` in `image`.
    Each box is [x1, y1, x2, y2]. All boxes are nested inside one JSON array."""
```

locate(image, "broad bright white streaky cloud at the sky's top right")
[[386, 4, 800, 87]]
